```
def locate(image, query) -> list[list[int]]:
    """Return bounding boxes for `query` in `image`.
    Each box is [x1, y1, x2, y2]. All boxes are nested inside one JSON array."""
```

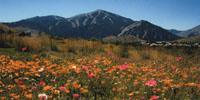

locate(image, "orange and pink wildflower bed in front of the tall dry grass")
[[0, 46, 200, 100]]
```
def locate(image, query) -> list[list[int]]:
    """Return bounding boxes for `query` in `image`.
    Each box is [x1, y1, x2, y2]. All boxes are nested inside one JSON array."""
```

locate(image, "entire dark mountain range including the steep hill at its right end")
[[5, 10, 178, 41]]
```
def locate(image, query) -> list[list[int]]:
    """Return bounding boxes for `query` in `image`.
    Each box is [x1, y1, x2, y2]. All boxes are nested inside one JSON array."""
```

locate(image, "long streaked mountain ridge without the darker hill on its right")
[[7, 10, 134, 38]]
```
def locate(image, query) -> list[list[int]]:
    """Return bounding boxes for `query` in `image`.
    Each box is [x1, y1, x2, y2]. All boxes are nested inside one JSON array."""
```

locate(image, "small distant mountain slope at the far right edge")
[[179, 25, 200, 37]]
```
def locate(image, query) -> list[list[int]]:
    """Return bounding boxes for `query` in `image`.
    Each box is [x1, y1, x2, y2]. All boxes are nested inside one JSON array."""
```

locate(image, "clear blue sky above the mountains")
[[0, 0, 200, 30]]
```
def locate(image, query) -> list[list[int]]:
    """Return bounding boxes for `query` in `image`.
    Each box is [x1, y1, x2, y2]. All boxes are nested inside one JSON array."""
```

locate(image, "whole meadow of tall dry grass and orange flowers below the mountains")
[[0, 39, 200, 100]]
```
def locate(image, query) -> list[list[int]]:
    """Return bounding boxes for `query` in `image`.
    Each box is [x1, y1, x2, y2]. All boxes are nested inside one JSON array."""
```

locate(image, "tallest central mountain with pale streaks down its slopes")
[[67, 10, 134, 38]]
